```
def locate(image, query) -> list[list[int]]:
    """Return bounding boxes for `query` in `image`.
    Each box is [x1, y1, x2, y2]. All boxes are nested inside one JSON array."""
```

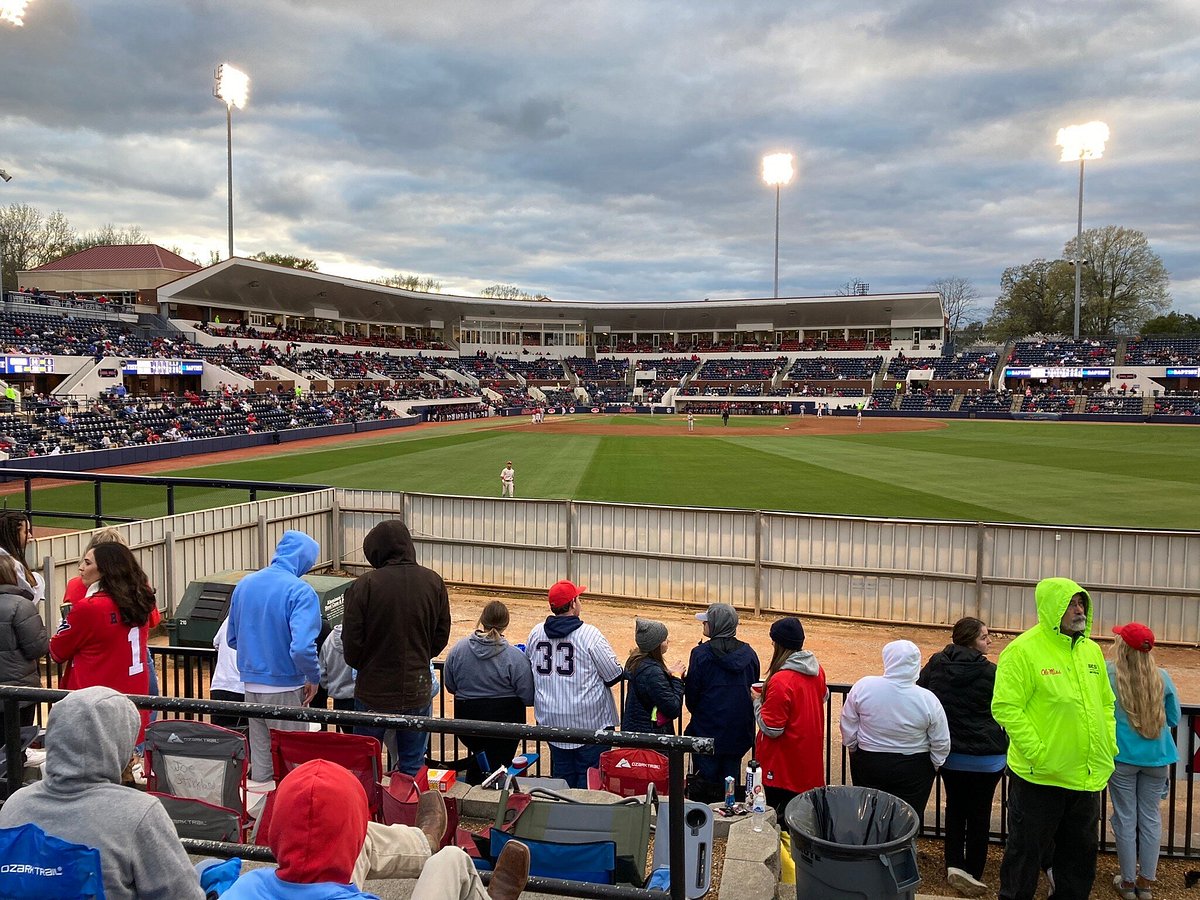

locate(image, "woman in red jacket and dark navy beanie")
[[754, 616, 829, 821]]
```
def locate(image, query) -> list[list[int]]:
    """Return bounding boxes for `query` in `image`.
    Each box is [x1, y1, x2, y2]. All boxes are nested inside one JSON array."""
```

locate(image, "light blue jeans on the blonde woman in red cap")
[[1109, 762, 1168, 882]]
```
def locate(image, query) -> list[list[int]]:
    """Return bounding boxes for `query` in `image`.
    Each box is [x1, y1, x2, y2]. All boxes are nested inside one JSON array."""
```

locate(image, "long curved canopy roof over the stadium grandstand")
[[158, 258, 943, 332]]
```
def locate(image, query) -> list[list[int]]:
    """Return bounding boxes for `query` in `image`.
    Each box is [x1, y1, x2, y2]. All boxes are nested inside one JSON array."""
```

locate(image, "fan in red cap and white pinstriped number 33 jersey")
[[526, 581, 623, 787]]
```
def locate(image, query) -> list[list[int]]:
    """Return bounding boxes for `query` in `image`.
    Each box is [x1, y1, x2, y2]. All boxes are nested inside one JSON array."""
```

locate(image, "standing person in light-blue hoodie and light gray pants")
[[226, 530, 320, 781]]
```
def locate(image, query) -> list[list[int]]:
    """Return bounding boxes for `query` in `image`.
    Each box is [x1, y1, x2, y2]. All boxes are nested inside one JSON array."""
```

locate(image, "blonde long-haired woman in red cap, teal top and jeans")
[[1108, 622, 1180, 900]]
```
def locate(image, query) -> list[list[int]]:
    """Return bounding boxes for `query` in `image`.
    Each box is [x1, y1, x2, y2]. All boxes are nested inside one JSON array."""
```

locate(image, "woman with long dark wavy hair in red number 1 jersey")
[[50, 541, 156, 742]]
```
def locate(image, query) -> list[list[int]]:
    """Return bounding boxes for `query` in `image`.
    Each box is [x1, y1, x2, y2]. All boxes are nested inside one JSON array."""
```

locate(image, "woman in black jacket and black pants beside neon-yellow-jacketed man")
[[917, 617, 1008, 896]]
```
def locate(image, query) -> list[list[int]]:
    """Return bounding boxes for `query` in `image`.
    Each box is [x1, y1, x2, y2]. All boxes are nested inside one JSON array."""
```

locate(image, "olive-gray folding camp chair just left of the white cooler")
[[493, 782, 658, 887]]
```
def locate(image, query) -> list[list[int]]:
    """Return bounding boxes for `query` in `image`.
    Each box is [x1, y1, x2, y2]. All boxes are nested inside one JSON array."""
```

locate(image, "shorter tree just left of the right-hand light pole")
[[988, 259, 1075, 341]]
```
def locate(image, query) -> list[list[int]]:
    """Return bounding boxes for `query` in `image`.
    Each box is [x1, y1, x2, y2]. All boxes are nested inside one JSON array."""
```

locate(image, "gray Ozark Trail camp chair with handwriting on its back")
[[145, 719, 250, 842]]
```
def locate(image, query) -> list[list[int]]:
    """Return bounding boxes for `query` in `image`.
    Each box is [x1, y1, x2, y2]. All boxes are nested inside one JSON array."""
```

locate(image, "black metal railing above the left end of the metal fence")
[[0, 467, 329, 528]]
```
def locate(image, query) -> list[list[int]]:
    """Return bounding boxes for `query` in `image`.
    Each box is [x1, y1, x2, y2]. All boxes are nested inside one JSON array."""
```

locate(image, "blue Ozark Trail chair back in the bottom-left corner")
[[0, 823, 104, 900]]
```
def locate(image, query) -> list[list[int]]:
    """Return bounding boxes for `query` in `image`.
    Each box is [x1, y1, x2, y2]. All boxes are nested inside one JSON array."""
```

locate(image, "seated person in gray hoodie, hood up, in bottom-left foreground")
[[0, 686, 204, 900]]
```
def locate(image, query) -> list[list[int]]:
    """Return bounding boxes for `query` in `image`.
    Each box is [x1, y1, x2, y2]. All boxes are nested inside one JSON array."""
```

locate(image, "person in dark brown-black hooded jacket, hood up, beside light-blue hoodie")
[[342, 520, 450, 775]]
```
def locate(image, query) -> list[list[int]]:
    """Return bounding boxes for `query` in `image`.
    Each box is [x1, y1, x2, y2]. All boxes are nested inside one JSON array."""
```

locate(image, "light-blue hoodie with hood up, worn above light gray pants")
[[226, 532, 320, 688]]
